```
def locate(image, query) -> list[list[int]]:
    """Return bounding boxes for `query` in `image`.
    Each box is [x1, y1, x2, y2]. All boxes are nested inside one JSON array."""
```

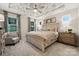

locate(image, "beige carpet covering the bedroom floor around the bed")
[[3, 39, 79, 56]]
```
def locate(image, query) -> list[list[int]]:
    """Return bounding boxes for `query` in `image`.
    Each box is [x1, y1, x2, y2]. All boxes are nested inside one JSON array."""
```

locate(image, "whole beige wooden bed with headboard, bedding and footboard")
[[26, 17, 58, 52]]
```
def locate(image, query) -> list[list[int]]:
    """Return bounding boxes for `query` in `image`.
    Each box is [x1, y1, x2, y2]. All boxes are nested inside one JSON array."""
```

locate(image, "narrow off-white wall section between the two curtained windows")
[[20, 15, 28, 39]]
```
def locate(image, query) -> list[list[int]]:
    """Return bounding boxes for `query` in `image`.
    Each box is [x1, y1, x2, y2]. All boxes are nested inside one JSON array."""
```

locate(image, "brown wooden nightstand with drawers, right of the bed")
[[58, 32, 76, 46]]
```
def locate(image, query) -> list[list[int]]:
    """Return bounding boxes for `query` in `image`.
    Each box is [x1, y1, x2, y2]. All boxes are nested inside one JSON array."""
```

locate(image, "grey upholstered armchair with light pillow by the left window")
[[5, 32, 19, 45]]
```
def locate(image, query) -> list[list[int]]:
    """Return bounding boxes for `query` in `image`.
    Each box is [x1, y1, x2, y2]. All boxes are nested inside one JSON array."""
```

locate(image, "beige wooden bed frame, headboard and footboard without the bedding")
[[26, 19, 58, 52]]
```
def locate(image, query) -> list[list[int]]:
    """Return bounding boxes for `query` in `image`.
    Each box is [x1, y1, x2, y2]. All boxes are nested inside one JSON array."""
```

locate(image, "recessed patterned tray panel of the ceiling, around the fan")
[[8, 3, 64, 17]]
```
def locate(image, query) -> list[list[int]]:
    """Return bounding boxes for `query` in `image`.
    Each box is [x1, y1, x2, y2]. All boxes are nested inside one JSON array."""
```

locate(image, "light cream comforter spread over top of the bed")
[[27, 31, 58, 41]]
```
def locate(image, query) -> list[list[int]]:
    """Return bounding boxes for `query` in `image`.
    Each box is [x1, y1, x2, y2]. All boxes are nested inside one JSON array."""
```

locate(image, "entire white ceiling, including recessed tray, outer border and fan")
[[0, 3, 78, 17]]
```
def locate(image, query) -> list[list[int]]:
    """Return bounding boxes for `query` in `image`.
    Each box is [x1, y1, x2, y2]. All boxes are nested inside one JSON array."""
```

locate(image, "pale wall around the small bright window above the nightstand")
[[54, 8, 78, 32]]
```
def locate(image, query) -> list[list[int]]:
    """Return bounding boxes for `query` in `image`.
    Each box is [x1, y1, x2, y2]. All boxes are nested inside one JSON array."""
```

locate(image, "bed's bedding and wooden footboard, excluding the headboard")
[[26, 31, 58, 52]]
